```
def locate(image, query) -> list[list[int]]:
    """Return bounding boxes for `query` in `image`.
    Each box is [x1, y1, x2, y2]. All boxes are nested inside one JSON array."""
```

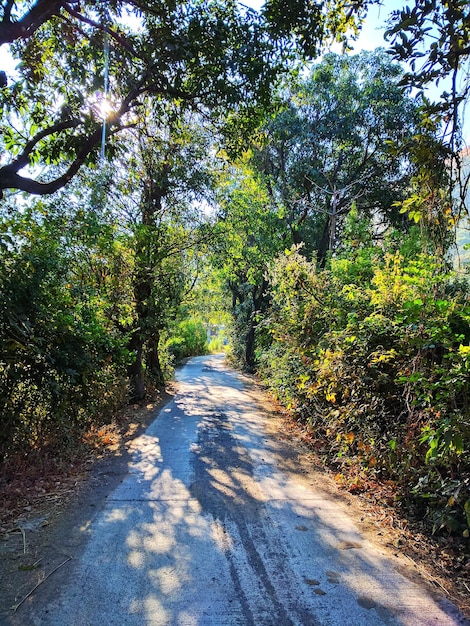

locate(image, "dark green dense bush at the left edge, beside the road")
[[0, 210, 132, 460]]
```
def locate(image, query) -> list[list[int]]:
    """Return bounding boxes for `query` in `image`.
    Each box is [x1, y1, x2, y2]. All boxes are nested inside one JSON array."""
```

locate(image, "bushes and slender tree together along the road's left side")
[[0, 92, 220, 456]]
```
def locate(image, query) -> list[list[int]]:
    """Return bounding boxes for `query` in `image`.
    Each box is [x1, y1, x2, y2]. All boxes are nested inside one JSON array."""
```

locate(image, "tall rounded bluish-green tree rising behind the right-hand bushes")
[[253, 50, 426, 260]]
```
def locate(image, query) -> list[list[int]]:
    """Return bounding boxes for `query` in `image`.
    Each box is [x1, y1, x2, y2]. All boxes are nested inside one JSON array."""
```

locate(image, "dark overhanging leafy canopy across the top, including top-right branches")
[[0, 0, 469, 194]]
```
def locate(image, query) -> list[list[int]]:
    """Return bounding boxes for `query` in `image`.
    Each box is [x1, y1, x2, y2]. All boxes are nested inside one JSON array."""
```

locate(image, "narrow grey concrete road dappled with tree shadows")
[[24, 356, 465, 626]]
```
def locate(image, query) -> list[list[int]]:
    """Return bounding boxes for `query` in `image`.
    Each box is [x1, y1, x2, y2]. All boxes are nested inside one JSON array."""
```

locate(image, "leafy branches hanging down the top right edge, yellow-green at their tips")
[[385, 0, 470, 224]]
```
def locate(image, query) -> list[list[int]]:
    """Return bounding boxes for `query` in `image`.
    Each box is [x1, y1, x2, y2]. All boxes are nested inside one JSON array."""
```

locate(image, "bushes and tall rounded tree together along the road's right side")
[[216, 51, 470, 539]]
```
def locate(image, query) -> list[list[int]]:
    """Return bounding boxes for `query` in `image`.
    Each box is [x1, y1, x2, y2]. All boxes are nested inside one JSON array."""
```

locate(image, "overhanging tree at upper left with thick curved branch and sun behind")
[[0, 0, 282, 195]]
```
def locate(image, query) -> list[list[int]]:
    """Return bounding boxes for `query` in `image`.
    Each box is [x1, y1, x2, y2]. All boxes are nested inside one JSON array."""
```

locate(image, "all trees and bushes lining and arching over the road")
[[0, 0, 470, 588]]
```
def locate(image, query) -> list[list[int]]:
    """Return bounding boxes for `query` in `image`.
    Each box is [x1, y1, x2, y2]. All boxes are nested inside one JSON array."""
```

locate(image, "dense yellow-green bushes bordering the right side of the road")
[[258, 227, 470, 537]]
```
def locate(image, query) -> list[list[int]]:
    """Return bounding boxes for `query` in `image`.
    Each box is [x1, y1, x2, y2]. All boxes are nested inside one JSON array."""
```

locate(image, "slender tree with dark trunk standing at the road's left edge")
[[117, 103, 213, 400]]
